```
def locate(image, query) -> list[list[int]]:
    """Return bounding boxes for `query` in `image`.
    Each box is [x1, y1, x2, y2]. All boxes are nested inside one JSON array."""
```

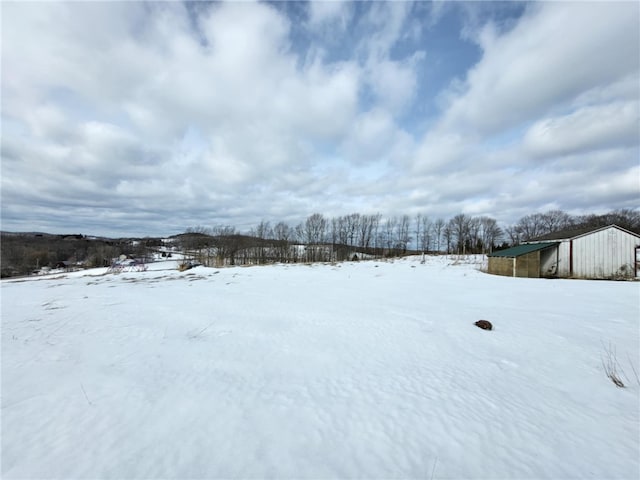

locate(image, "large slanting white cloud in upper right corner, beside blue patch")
[[443, 2, 640, 134]]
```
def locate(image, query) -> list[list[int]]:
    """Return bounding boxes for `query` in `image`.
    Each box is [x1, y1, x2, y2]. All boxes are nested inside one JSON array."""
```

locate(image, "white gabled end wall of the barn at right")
[[573, 227, 640, 278]]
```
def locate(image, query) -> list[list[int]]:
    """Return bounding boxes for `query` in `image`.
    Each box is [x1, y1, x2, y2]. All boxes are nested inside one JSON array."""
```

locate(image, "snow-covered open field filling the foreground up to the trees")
[[1, 257, 640, 479]]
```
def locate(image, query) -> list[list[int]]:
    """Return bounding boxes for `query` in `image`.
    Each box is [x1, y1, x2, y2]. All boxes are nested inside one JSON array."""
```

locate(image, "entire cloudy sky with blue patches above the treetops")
[[0, 1, 640, 236]]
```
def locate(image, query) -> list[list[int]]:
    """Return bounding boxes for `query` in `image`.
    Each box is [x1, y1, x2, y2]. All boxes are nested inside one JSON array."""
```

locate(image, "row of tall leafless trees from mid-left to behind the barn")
[[178, 209, 640, 265]]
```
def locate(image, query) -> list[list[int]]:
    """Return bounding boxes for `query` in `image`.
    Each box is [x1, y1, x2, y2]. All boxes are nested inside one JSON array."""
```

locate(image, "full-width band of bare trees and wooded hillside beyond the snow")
[[0, 209, 640, 277]]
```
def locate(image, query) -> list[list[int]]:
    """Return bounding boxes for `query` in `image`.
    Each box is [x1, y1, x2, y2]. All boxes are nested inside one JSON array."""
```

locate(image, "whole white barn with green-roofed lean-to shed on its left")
[[489, 225, 640, 278]]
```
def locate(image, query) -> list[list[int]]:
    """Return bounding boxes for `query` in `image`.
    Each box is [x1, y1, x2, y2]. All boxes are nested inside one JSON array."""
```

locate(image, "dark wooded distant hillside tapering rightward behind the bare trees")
[[0, 232, 416, 278]]
